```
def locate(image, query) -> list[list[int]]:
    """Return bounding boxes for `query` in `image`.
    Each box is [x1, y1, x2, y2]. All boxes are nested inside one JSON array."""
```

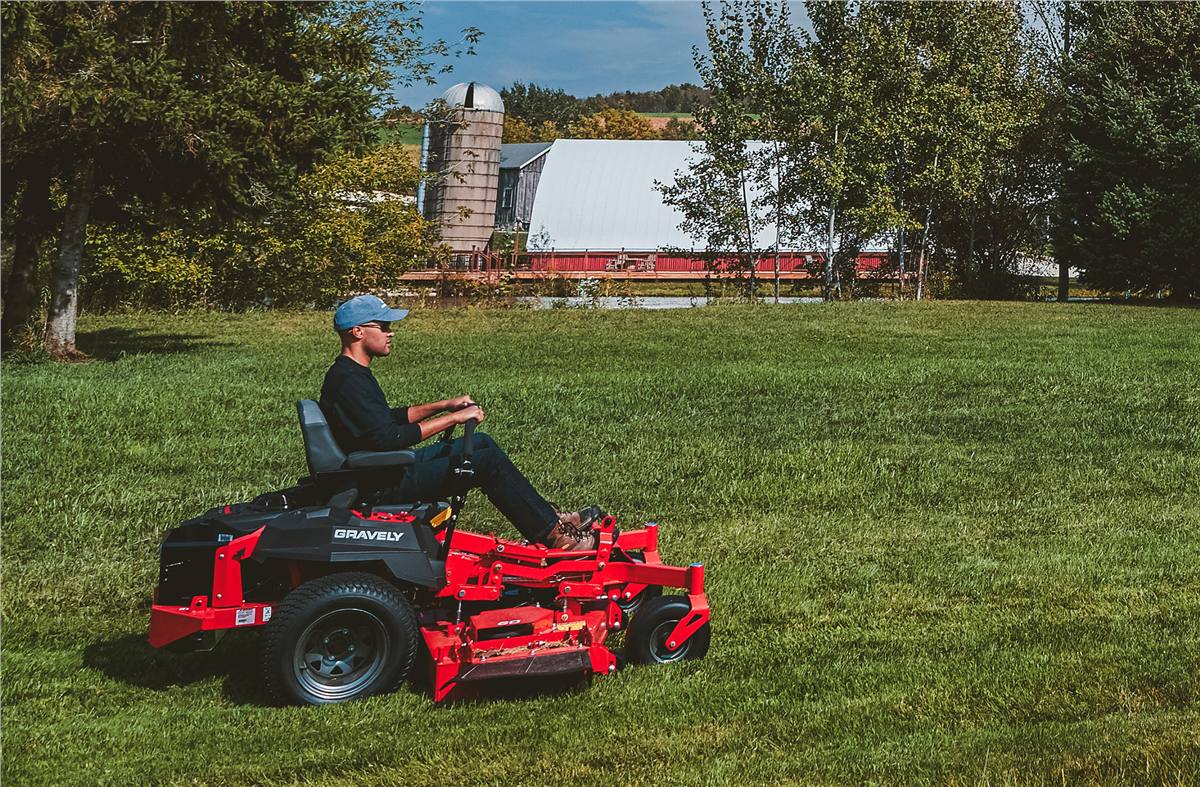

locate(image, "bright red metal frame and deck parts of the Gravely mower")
[[150, 511, 709, 702]]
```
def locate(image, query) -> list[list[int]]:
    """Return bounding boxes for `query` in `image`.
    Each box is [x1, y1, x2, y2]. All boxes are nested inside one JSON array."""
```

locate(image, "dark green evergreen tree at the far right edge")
[[1056, 2, 1200, 299]]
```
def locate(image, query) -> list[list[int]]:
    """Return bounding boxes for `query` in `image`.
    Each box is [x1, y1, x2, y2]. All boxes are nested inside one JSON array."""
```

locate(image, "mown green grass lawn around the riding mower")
[[0, 302, 1200, 785]]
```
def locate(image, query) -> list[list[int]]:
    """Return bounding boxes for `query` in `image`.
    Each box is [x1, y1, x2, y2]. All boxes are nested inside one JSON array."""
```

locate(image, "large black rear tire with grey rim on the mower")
[[262, 573, 419, 705]]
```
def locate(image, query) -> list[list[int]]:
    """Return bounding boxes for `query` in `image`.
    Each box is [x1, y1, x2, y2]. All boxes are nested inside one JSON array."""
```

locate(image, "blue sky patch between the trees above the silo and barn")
[[396, 0, 704, 107]]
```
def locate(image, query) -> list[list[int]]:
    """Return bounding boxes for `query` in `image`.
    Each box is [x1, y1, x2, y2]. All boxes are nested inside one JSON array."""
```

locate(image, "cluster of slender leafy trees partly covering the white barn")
[[666, 0, 1048, 296]]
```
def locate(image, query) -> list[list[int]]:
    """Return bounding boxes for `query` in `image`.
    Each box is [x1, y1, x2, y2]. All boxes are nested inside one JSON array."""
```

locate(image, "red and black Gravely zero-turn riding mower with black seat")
[[150, 399, 709, 704]]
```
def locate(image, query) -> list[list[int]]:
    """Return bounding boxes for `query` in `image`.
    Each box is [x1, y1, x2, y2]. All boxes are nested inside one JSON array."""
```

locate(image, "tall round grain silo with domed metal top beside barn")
[[422, 82, 504, 253]]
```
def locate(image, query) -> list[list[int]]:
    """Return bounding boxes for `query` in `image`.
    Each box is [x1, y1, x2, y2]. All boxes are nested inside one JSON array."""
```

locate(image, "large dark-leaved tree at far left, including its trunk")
[[2, 2, 472, 355]]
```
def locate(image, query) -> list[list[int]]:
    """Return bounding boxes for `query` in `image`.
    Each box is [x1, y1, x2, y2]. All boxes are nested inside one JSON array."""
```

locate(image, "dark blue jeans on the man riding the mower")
[[371, 432, 558, 541]]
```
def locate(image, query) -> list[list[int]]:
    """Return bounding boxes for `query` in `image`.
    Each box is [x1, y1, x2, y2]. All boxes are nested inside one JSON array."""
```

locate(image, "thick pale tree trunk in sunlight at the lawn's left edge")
[[46, 157, 96, 359]]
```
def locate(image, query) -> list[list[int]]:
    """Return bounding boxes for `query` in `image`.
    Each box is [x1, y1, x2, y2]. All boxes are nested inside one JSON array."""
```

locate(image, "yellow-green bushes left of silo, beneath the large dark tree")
[[83, 144, 437, 308]]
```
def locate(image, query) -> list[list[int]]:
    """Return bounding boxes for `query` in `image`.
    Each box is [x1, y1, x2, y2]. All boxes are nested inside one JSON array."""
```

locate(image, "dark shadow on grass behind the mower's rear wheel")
[[83, 632, 270, 705]]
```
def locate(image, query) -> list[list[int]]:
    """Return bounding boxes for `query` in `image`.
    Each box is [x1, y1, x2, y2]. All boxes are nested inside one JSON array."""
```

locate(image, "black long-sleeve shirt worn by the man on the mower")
[[320, 355, 421, 453]]
